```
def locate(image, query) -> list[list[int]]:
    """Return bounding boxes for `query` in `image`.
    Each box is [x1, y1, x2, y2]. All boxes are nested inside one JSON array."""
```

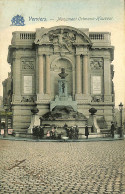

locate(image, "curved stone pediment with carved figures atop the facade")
[[35, 26, 92, 49]]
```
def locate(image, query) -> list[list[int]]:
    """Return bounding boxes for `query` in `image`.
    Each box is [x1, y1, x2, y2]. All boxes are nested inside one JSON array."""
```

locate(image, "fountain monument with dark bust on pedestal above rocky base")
[[40, 68, 87, 136]]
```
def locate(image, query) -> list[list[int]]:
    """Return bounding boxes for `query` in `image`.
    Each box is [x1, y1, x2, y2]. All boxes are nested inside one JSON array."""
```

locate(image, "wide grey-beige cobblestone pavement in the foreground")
[[0, 140, 125, 194]]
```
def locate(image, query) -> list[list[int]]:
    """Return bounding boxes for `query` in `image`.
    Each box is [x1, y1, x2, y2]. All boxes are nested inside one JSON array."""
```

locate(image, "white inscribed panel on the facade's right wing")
[[92, 76, 101, 94]]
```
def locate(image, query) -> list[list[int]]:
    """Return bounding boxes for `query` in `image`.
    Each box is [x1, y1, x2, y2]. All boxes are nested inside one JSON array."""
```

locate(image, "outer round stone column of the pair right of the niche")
[[83, 55, 88, 94]]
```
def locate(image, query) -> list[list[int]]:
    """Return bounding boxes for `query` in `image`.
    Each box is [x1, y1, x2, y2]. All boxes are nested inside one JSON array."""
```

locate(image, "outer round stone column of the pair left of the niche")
[[38, 55, 44, 94]]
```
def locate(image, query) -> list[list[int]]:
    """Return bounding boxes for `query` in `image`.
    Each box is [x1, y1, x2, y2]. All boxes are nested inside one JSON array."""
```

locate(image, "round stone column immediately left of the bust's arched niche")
[[46, 55, 50, 94]]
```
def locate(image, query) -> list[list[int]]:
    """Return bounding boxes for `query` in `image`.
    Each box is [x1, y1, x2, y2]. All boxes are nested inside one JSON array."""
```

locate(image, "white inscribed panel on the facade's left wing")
[[24, 76, 32, 94]]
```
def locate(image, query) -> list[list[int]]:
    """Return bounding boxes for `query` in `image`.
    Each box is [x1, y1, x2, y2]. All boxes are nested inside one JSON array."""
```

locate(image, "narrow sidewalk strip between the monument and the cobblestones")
[[0, 135, 124, 142]]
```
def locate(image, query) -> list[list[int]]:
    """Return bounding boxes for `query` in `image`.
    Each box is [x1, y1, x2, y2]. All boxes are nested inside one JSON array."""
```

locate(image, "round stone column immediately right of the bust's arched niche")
[[76, 55, 81, 94]]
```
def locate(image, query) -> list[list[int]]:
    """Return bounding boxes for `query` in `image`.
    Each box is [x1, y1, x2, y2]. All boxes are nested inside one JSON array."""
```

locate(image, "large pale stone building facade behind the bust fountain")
[[8, 26, 114, 134]]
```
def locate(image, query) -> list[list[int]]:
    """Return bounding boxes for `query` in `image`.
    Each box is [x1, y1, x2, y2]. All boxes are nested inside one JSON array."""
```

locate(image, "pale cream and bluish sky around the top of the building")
[[0, 0, 125, 106]]
